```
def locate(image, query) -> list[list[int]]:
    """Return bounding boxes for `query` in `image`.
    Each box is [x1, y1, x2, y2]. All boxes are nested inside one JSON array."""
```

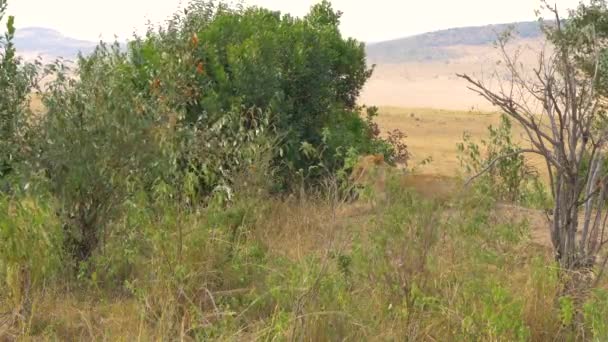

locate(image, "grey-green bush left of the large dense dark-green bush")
[[37, 45, 167, 261]]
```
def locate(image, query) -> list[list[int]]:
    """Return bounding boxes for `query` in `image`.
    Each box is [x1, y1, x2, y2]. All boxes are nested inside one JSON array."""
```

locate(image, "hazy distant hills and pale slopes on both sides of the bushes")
[[16, 22, 543, 110]]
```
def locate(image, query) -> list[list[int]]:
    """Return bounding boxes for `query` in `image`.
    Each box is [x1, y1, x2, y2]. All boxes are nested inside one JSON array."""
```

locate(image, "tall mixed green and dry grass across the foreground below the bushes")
[[0, 175, 606, 341]]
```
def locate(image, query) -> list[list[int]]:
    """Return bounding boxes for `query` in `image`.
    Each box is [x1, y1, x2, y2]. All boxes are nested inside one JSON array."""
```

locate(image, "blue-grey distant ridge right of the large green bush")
[[367, 21, 542, 64]]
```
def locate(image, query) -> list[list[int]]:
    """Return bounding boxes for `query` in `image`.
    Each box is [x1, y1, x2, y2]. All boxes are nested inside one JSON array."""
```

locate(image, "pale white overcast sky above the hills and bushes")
[[9, 0, 579, 42]]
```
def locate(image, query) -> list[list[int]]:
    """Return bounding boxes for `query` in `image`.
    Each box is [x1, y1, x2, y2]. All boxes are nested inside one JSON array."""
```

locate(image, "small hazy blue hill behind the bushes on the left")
[[15, 27, 97, 59]]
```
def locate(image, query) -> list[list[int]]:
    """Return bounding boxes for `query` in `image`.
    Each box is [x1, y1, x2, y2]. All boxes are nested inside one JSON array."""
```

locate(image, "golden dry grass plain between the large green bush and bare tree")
[[377, 107, 551, 248]]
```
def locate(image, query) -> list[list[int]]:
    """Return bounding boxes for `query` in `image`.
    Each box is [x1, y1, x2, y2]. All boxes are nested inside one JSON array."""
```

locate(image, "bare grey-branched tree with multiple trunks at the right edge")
[[458, 4, 608, 270]]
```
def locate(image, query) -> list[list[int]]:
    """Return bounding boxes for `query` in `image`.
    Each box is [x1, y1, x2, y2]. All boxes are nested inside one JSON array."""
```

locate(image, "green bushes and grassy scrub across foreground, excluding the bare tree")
[[0, 0, 608, 341]]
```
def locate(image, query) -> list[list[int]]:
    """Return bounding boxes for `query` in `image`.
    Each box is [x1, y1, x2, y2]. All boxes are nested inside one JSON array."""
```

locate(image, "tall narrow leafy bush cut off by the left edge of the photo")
[[0, 0, 61, 324]]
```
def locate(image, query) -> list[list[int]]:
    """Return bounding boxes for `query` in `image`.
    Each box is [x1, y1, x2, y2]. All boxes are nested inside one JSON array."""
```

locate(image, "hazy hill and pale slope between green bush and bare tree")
[[360, 22, 548, 111]]
